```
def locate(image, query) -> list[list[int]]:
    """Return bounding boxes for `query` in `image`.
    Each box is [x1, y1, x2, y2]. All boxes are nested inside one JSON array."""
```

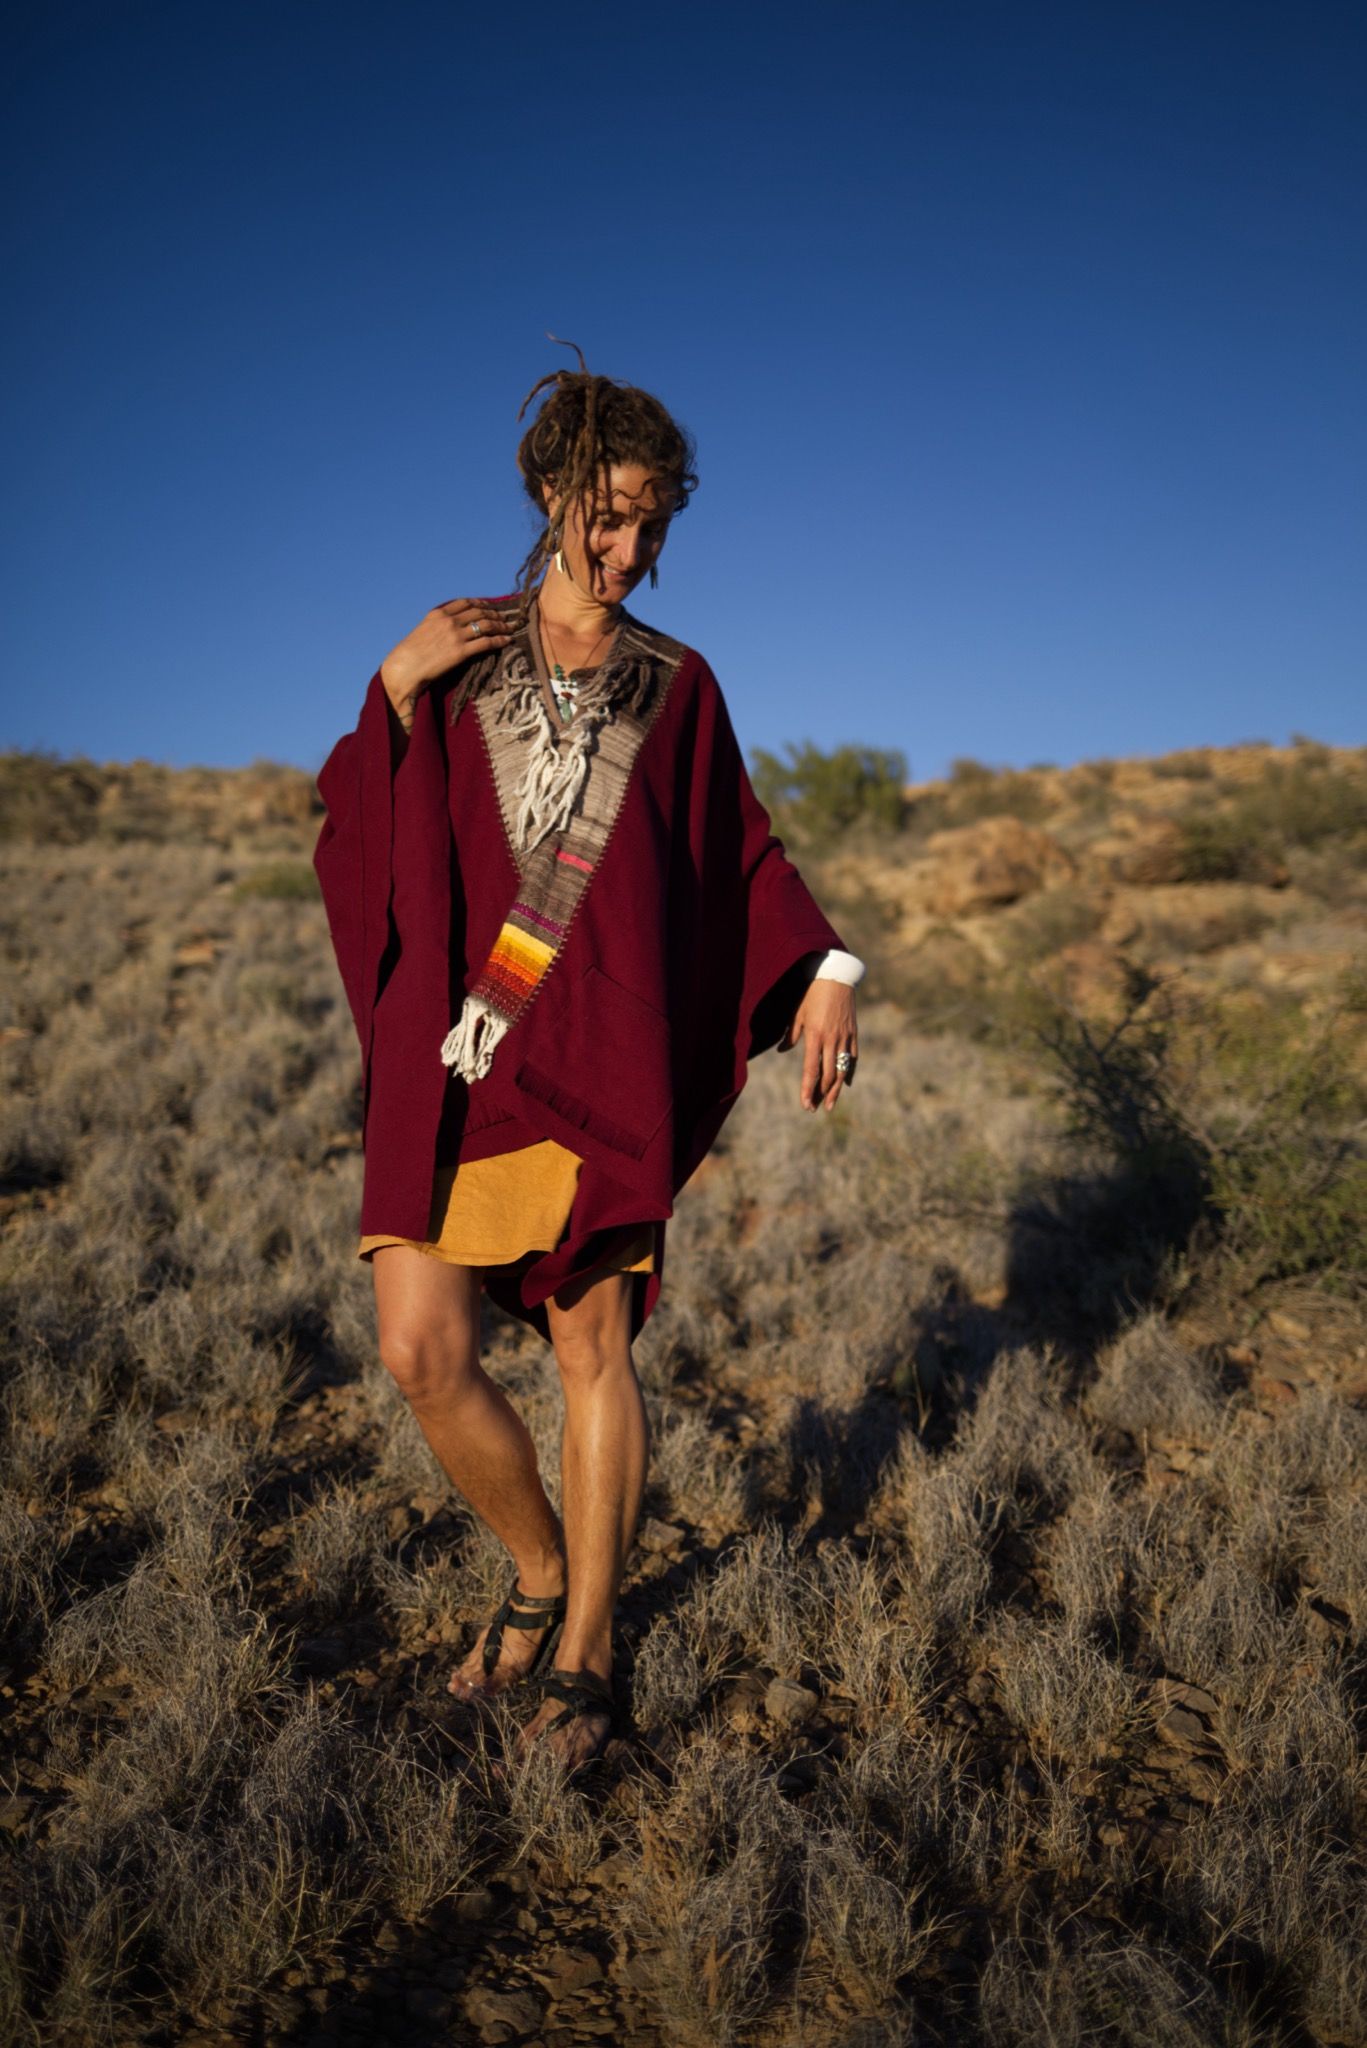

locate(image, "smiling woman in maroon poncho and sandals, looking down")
[[316, 356, 863, 1765]]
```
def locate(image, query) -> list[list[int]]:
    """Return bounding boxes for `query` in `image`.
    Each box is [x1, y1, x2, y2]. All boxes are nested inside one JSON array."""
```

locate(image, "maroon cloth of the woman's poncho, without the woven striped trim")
[[314, 623, 842, 1339]]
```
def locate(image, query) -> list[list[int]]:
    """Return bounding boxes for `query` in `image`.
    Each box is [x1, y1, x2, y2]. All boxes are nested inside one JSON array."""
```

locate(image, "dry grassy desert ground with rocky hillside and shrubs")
[[0, 741, 1367, 2048]]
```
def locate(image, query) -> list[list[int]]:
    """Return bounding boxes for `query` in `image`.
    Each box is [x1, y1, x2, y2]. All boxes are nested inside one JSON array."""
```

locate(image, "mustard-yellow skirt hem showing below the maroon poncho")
[[359, 1139, 656, 1274]]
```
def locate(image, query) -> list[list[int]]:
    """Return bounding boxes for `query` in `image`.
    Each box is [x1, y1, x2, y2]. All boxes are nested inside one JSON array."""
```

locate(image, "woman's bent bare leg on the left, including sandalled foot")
[[371, 1245, 566, 1698]]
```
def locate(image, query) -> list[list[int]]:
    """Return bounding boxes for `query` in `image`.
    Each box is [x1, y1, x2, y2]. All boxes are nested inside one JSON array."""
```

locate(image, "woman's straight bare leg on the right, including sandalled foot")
[[523, 1274, 650, 1763]]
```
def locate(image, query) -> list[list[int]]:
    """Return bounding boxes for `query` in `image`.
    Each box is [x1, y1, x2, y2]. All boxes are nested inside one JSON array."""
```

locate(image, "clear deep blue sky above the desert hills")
[[0, 0, 1367, 776]]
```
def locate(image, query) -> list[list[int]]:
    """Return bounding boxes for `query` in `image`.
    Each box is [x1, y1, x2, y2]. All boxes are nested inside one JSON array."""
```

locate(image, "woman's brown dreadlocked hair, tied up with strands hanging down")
[[451, 334, 697, 723]]
